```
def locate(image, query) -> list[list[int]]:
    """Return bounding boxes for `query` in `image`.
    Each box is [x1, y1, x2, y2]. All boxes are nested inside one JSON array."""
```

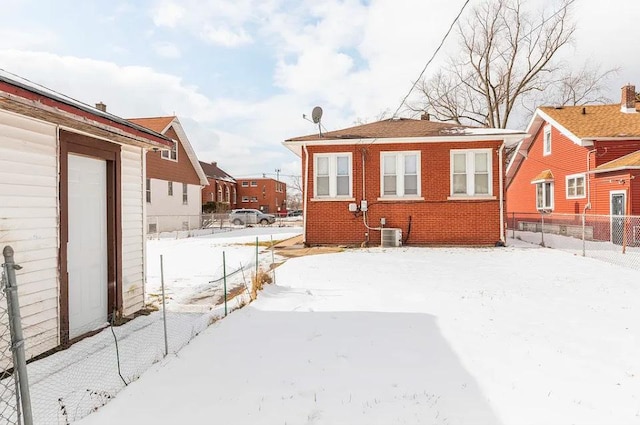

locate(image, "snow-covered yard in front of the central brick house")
[[76, 242, 640, 424]]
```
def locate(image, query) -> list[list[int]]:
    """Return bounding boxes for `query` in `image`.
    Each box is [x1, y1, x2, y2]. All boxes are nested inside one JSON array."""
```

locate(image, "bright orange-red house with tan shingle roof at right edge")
[[506, 85, 640, 239]]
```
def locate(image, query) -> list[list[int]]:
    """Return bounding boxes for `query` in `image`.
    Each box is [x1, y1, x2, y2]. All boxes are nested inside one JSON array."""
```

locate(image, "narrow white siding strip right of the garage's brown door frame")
[[121, 146, 145, 316]]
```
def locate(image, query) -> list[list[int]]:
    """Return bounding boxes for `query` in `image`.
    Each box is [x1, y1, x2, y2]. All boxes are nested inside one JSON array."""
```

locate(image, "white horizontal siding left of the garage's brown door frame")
[[0, 107, 60, 358]]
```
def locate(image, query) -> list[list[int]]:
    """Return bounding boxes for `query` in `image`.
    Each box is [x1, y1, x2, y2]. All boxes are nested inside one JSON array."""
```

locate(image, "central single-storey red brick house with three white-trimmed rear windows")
[[284, 116, 524, 245]]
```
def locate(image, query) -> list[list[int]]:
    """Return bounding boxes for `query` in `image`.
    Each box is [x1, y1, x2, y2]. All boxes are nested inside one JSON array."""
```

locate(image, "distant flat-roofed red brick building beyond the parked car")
[[237, 177, 287, 215]]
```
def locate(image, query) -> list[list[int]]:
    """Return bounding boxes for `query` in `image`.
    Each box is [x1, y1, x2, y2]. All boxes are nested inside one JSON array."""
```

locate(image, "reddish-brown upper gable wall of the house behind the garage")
[[147, 127, 200, 185]]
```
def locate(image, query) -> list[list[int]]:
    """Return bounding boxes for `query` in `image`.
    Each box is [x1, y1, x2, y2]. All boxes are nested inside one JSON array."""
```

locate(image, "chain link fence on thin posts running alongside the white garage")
[[0, 239, 274, 425]]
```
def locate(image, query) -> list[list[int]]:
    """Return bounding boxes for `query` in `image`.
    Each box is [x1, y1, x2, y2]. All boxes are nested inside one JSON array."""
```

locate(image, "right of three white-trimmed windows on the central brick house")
[[451, 149, 493, 197]]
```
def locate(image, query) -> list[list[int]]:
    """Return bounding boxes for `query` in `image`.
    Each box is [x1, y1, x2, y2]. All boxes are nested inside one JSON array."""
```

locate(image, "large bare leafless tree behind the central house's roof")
[[411, 0, 614, 128]]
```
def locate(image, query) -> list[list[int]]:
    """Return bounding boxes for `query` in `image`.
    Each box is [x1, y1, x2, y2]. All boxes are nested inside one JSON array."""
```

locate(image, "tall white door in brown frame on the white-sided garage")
[[67, 155, 107, 338]]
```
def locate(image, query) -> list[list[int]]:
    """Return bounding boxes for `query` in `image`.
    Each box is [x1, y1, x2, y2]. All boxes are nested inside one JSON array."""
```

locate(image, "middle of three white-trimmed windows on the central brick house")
[[380, 151, 420, 197]]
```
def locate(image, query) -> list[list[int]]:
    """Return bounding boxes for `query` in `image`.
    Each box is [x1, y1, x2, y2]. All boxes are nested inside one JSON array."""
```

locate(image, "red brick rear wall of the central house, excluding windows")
[[302, 141, 501, 245]]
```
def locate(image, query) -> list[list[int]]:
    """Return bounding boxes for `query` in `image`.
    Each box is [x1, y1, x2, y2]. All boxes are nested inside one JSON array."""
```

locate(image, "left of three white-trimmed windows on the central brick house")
[[313, 153, 353, 198]]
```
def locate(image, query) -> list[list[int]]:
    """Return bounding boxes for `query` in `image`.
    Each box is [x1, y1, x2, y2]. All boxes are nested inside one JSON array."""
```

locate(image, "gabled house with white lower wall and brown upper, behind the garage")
[[129, 116, 209, 233]]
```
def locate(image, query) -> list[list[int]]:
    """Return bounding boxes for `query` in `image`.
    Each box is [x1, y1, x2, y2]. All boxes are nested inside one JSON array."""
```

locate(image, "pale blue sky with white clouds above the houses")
[[0, 0, 640, 181]]
